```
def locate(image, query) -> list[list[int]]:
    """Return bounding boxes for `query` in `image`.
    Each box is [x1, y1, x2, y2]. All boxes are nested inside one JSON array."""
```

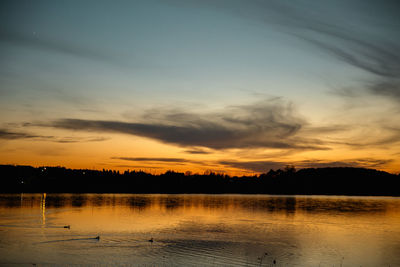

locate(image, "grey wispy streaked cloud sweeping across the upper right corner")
[[175, 0, 400, 101]]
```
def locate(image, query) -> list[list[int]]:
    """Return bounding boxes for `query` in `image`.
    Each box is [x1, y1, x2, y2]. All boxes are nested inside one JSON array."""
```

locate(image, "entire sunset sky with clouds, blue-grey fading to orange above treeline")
[[0, 0, 400, 175]]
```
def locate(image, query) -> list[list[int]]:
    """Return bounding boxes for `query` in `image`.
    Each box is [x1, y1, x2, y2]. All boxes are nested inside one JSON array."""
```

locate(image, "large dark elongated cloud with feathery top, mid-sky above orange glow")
[[41, 98, 327, 150]]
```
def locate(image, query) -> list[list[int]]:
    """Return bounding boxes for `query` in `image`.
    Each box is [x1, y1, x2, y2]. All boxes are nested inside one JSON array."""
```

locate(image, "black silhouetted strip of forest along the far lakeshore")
[[0, 165, 400, 196]]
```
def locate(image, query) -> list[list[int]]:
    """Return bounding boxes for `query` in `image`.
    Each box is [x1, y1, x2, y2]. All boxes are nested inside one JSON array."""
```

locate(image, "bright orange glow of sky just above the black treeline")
[[0, 130, 400, 176]]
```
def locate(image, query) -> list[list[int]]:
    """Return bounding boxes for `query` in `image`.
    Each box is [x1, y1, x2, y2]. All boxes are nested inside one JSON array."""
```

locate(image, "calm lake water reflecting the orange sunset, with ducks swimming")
[[0, 194, 400, 267]]
